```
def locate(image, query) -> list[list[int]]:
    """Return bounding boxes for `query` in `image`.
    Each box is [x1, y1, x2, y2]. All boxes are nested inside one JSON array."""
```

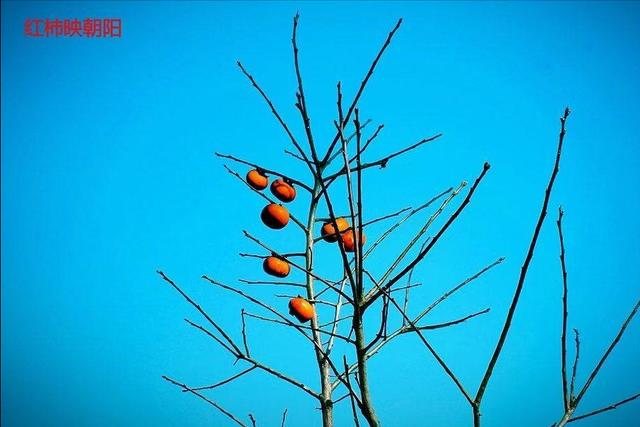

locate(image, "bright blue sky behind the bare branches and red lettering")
[[1, 2, 640, 427]]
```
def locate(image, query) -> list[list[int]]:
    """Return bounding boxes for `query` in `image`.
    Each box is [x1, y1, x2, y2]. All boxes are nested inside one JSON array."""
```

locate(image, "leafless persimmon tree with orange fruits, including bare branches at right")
[[158, 11, 640, 427]]
